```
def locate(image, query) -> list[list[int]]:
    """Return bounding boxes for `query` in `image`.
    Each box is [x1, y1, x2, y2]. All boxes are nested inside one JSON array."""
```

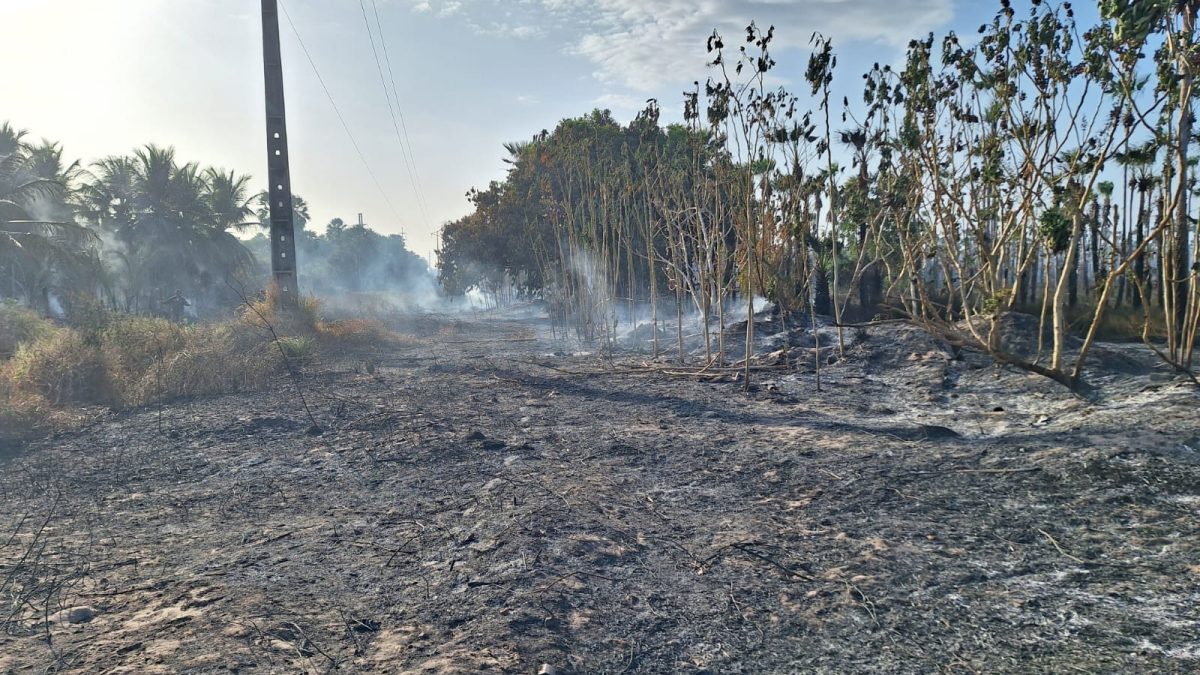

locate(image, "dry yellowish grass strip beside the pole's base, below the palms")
[[0, 292, 410, 443]]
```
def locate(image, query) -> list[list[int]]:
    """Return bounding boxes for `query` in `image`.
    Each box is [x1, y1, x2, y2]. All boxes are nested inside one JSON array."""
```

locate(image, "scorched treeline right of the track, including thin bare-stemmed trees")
[[438, 0, 1200, 384]]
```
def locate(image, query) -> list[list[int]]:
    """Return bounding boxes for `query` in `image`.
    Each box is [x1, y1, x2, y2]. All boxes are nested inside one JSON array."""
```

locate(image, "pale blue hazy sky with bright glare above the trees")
[[0, 0, 1094, 257]]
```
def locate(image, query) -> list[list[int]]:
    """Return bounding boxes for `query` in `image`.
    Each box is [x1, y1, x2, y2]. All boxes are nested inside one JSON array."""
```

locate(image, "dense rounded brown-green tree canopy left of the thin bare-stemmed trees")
[[438, 109, 731, 299]]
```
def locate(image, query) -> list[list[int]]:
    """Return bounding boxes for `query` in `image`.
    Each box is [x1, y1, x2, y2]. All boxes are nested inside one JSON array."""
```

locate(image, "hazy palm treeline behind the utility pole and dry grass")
[[0, 123, 428, 316]]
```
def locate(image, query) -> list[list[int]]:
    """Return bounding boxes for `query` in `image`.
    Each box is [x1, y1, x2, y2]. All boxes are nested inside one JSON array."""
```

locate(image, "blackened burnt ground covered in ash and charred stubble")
[[0, 312, 1200, 674]]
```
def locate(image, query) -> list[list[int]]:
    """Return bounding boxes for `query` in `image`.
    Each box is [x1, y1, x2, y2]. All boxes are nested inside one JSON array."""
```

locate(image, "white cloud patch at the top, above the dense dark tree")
[[410, 0, 955, 91]]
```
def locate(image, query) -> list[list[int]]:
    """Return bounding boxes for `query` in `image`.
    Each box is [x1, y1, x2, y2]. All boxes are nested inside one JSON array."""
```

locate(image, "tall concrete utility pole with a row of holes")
[[263, 0, 299, 300]]
